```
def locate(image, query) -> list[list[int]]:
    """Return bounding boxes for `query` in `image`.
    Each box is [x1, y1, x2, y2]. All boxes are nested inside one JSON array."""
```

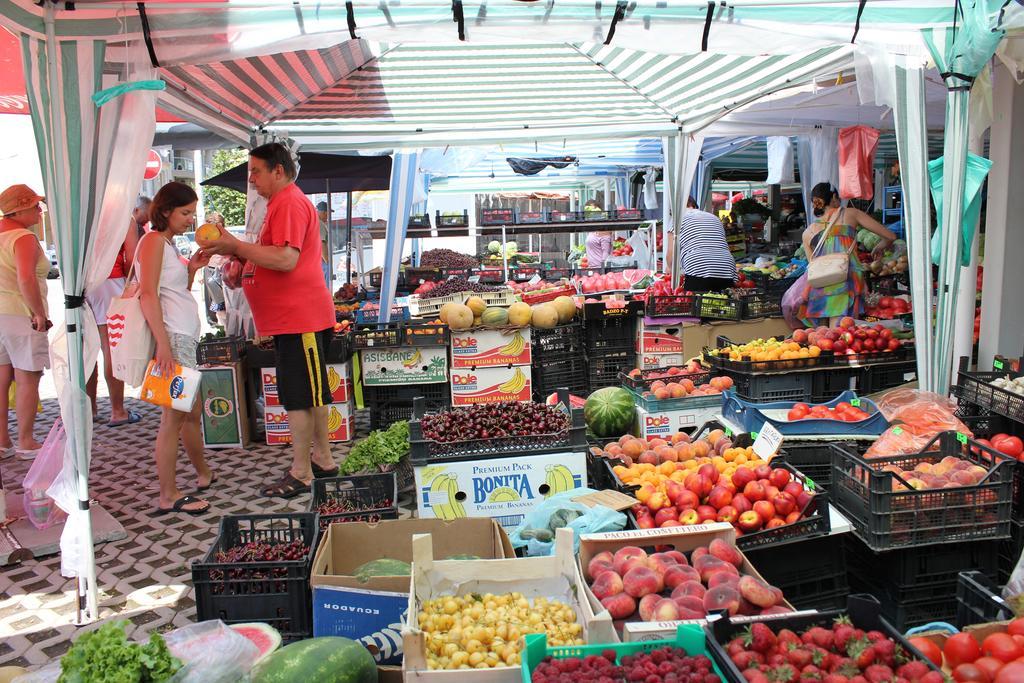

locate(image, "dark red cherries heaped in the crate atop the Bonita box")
[[421, 401, 570, 443]]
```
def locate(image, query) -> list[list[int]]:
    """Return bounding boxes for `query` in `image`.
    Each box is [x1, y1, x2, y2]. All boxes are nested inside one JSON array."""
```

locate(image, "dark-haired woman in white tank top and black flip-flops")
[[136, 182, 215, 515]]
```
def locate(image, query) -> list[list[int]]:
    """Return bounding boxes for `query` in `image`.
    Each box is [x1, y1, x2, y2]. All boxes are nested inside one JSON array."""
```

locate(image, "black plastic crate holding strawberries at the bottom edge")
[[705, 595, 939, 682]]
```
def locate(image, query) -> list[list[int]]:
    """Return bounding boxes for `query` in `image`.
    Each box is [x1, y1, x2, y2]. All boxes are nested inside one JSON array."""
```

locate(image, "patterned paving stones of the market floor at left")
[[0, 399, 410, 667]]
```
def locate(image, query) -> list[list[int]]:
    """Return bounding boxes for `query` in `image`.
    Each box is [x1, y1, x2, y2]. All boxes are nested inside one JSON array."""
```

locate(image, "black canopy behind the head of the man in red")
[[202, 152, 391, 195]]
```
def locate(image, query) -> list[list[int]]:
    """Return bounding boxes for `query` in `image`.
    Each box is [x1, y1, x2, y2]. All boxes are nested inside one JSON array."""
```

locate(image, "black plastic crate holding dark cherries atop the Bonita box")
[[409, 396, 588, 466]]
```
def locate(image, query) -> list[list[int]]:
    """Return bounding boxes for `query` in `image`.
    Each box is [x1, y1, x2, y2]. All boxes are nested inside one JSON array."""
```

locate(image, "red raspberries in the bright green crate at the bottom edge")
[[531, 646, 722, 683]]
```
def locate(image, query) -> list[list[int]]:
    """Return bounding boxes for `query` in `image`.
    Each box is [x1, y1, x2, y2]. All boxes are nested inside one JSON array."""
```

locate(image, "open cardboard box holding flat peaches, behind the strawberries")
[[577, 522, 793, 643]]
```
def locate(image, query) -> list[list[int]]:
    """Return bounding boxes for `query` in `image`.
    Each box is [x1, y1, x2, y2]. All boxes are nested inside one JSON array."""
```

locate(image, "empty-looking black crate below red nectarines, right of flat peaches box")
[[743, 537, 850, 609]]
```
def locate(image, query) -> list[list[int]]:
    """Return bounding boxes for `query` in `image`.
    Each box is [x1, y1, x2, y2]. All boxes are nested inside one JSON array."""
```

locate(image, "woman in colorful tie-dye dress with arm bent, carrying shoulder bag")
[[800, 182, 896, 327]]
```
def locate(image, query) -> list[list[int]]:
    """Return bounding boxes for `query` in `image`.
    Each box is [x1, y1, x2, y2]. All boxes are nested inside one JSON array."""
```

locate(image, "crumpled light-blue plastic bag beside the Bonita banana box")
[[509, 488, 626, 557]]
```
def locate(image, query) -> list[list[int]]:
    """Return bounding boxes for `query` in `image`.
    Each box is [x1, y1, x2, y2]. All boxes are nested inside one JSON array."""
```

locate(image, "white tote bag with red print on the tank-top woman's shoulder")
[[106, 260, 157, 387]]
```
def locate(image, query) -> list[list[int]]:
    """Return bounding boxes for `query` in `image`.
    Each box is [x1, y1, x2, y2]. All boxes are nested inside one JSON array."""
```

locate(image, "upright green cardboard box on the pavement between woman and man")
[[199, 362, 249, 449]]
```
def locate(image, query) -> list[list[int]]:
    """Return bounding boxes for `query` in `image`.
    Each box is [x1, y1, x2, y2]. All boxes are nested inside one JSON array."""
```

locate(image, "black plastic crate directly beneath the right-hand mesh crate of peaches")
[[844, 533, 998, 603]]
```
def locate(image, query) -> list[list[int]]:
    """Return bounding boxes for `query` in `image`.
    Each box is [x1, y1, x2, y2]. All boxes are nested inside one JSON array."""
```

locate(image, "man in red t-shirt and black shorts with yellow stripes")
[[197, 142, 338, 498]]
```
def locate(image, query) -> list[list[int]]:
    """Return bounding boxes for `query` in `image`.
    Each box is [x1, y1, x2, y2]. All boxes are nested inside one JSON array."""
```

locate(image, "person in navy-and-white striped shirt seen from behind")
[[672, 197, 736, 292]]
